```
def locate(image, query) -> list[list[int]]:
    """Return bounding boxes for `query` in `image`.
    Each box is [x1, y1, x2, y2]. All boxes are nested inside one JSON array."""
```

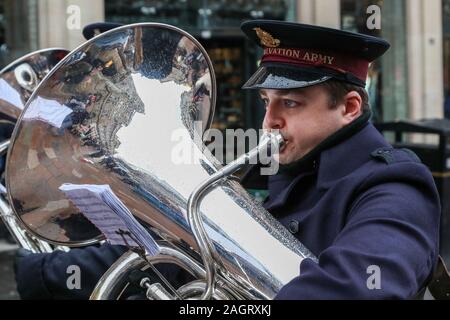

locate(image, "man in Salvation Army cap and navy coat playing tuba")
[[13, 20, 440, 299]]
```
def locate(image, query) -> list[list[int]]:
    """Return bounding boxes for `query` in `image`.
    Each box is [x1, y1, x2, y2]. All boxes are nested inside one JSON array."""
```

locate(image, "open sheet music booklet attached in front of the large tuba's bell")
[[59, 184, 160, 256]]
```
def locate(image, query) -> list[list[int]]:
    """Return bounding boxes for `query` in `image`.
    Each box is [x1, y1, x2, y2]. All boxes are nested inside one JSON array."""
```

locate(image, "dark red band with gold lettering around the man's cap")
[[262, 48, 369, 82]]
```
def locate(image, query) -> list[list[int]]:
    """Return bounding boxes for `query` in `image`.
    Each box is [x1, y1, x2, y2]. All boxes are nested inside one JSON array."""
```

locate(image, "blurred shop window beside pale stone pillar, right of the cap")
[[341, 0, 408, 122]]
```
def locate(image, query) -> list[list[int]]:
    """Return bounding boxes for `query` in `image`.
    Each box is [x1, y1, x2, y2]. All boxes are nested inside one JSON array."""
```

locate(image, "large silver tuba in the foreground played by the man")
[[7, 23, 314, 299]]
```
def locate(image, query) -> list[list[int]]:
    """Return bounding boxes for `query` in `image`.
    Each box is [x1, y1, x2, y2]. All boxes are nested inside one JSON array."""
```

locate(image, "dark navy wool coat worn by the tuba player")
[[16, 124, 440, 299]]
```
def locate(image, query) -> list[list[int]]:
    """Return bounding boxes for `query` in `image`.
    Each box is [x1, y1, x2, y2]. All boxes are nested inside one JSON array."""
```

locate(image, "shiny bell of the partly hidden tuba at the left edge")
[[0, 48, 69, 120]]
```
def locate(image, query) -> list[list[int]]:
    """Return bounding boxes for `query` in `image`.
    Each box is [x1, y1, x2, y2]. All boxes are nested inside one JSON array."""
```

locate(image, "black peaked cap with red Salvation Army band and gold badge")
[[241, 20, 390, 89]]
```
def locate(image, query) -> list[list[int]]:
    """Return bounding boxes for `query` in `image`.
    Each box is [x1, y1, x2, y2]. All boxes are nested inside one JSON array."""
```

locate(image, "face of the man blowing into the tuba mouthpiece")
[[260, 86, 348, 164]]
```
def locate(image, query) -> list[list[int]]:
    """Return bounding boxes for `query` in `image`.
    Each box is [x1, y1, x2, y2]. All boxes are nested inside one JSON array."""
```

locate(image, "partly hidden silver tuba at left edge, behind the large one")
[[0, 48, 69, 253]]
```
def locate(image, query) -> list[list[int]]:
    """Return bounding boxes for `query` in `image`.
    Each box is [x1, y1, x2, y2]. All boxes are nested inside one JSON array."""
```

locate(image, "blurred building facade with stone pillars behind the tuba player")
[[0, 0, 450, 129]]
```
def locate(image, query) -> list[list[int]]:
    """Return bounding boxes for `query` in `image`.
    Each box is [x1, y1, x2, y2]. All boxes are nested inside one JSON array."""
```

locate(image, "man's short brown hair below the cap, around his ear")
[[319, 79, 370, 113]]
